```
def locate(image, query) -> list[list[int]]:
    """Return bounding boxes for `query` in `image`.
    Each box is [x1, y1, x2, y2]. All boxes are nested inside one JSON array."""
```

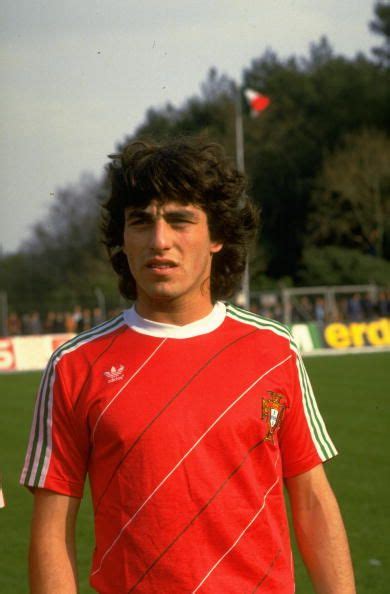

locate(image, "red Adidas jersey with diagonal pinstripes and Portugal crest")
[[21, 303, 336, 594]]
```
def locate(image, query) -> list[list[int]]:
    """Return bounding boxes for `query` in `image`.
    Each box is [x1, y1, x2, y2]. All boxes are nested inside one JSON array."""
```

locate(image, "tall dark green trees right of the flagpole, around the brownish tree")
[[244, 40, 390, 278]]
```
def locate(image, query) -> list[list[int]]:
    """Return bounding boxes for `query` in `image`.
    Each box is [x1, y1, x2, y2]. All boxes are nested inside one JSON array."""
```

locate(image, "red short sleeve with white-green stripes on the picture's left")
[[20, 358, 89, 497]]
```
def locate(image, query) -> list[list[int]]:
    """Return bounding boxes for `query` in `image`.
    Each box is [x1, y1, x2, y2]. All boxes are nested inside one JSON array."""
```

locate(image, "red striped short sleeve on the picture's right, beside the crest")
[[279, 345, 337, 477]]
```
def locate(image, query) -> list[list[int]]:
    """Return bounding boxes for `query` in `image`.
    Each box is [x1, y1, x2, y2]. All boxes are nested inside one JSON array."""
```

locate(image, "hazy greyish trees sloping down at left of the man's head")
[[0, 176, 118, 313]]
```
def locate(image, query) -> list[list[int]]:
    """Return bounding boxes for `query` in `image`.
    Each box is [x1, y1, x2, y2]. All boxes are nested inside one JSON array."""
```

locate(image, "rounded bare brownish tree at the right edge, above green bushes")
[[309, 130, 390, 257]]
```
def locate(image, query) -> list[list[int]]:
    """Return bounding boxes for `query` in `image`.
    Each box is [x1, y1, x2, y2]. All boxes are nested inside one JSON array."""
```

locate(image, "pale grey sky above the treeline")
[[0, 0, 377, 253]]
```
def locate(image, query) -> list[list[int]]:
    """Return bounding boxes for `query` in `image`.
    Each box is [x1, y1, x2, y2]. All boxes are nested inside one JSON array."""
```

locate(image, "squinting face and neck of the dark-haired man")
[[123, 200, 222, 321]]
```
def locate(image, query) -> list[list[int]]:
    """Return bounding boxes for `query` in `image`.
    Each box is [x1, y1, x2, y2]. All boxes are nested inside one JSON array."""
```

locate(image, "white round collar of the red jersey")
[[124, 301, 226, 338]]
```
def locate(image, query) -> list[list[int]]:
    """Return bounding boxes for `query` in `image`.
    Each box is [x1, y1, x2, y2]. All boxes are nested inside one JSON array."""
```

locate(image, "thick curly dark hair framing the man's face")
[[102, 139, 258, 301]]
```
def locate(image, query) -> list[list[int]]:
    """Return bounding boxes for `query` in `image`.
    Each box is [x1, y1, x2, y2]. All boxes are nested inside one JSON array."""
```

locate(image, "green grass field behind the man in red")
[[0, 353, 390, 594]]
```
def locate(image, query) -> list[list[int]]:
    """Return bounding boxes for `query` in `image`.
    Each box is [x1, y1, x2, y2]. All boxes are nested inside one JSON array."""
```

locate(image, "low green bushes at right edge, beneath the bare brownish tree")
[[299, 246, 390, 286]]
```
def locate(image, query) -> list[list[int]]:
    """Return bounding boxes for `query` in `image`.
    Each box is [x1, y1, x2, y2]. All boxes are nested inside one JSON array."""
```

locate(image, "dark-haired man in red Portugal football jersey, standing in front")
[[22, 136, 355, 594]]
